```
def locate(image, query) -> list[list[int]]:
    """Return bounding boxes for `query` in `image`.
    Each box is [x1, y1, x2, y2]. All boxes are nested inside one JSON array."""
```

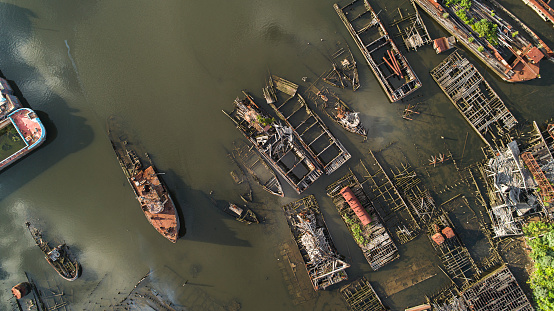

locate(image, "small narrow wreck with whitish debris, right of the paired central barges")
[[308, 85, 367, 138]]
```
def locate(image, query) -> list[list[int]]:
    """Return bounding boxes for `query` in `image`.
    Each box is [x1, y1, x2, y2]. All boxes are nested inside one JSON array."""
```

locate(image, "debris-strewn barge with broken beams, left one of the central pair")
[[223, 92, 323, 194]]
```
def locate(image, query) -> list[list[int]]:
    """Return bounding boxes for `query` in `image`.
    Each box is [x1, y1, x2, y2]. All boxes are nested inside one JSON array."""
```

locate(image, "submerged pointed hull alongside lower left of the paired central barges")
[[232, 140, 284, 197]]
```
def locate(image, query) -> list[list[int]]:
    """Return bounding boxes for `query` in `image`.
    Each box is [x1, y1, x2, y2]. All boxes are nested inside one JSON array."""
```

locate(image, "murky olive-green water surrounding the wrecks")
[[0, 0, 554, 310]]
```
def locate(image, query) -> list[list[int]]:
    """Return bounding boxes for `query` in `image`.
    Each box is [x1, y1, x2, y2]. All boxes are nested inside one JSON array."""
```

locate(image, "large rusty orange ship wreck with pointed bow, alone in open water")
[[108, 116, 180, 243]]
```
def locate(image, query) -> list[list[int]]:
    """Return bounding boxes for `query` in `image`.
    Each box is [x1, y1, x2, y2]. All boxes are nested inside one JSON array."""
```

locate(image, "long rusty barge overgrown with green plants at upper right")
[[414, 0, 554, 82]]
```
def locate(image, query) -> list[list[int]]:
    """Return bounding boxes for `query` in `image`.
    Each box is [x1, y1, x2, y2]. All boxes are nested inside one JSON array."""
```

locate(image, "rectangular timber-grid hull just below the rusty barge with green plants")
[[431, 51, 517, 146]]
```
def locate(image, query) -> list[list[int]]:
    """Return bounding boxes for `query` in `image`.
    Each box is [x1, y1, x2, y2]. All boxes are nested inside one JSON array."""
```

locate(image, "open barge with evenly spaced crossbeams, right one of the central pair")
[[266, 75, 351, 175]]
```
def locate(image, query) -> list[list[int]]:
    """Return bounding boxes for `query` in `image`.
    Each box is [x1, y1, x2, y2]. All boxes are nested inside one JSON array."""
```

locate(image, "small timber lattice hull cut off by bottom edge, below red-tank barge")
[[340, 277, 386, 311]]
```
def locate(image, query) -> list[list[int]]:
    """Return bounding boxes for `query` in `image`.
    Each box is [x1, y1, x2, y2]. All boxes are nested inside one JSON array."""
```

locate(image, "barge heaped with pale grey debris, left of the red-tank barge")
[[283, 195, 350, 291]]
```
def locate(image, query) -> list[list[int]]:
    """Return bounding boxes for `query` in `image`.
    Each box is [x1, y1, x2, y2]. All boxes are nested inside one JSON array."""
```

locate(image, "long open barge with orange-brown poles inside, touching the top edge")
[[333, 0, 421, 102]]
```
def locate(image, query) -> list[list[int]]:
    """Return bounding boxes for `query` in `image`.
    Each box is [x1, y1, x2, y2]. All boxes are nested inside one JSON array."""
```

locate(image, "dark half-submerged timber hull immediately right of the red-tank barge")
[[360, 150, 421, 244]]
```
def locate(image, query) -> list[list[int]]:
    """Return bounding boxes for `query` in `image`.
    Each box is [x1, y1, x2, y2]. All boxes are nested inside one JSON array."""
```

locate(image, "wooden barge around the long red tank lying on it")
[[326, 172, 399, 271]]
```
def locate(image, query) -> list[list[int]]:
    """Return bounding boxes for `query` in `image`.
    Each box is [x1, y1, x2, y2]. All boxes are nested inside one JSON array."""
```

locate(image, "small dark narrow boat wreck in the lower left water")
[[25, 222, 81, 281]]
